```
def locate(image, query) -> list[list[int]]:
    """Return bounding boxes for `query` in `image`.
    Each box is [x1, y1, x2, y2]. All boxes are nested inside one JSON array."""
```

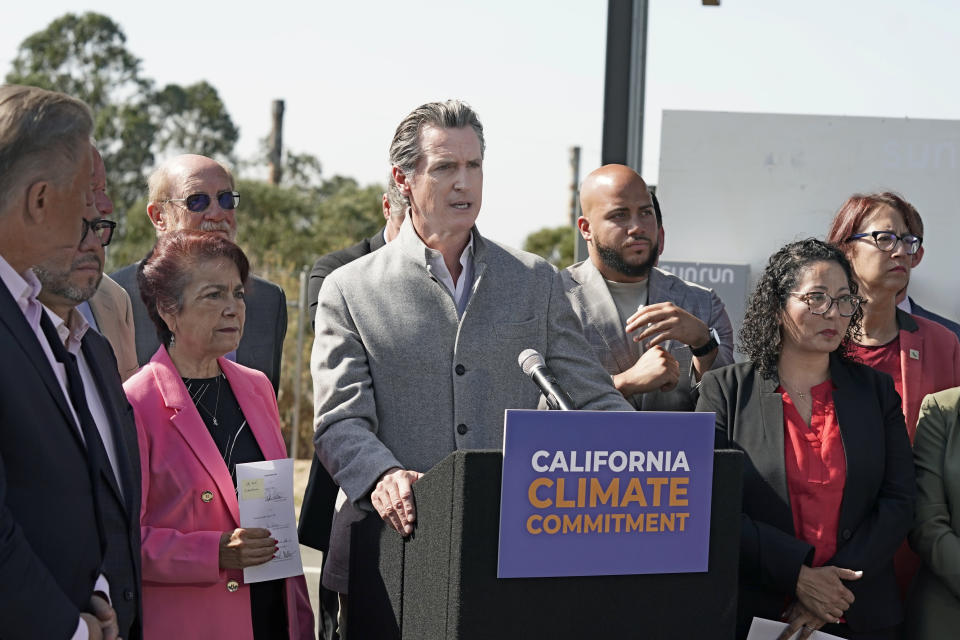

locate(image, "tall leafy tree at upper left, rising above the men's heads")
[[6, 12, 238, 228]]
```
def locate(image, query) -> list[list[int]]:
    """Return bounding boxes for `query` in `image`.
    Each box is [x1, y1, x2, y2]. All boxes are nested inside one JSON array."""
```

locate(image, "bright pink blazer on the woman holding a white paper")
[[123, 346, 314, 640]]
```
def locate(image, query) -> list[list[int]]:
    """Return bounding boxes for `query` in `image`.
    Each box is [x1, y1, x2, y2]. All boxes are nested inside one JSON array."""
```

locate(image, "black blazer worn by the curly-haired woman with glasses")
[[697, 356, 916, 635]]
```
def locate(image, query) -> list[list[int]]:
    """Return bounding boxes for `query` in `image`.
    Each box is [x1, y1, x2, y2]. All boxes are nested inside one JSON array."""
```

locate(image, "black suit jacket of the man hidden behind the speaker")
[[298, 229, 386, 551]]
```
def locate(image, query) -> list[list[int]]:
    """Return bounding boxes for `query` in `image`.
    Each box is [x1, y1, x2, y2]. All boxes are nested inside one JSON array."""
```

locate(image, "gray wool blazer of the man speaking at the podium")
[[310, 222, 632, 504]]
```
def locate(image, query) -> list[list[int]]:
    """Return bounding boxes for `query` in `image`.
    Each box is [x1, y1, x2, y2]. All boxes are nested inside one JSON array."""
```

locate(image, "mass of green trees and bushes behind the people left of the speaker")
[[6, 12, 383, 456]]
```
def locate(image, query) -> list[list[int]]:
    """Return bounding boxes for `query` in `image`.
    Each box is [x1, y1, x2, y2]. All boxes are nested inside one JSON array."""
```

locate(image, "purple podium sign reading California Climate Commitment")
[[497, 410, 714, 578]]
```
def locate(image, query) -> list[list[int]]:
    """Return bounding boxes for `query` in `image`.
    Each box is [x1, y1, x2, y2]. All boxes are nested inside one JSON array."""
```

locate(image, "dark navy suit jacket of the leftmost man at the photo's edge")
[[0, 284, 109, 638]]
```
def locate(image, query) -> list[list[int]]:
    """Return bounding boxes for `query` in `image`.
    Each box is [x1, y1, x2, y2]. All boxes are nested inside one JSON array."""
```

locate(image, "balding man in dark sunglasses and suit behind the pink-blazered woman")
[[110, 155, 287, 391]]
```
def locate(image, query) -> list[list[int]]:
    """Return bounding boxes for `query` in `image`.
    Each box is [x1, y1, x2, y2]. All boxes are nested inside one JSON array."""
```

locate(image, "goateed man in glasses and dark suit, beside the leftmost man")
[[33, 142, 142, 639]]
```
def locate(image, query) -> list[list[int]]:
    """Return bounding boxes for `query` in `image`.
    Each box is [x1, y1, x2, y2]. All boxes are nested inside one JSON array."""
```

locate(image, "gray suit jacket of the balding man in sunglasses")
[[110, 262, 287, 392]]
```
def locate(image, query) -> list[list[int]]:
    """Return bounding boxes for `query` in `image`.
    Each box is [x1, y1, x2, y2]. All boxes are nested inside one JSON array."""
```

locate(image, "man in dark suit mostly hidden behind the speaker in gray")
[[298, 178, 410, 640]]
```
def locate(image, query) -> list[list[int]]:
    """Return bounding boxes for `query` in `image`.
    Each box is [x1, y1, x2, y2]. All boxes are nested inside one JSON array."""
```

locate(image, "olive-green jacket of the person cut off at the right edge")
[[905, 387, 960, 640]]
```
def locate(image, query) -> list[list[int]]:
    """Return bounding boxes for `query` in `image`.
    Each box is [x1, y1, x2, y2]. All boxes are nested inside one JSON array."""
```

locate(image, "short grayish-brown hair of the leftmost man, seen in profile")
[[0, 84, 93, 213]]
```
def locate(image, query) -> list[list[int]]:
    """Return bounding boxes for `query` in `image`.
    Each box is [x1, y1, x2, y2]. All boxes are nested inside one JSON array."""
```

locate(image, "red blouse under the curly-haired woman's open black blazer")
[[777, 380, 847, 567]]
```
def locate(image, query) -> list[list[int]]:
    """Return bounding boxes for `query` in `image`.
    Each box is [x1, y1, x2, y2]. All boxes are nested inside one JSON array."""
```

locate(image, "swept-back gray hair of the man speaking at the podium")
[[390, 100, 487, 175]]
